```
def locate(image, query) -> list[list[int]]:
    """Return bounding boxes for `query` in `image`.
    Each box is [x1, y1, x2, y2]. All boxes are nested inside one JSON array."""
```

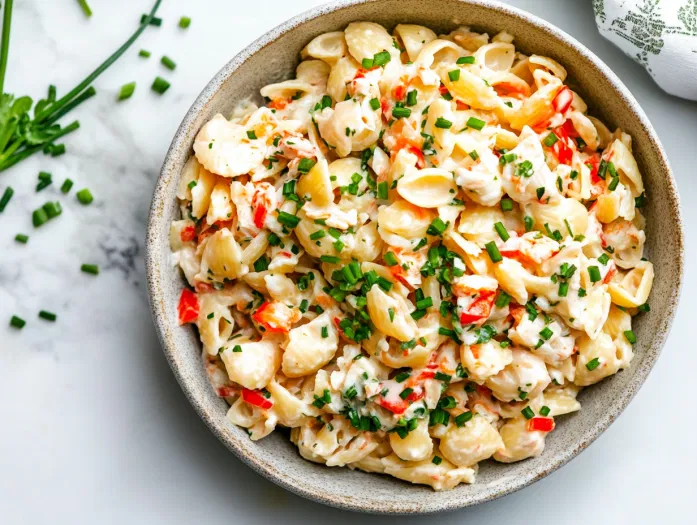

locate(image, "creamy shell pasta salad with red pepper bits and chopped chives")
[[170, 22, 654, 490]]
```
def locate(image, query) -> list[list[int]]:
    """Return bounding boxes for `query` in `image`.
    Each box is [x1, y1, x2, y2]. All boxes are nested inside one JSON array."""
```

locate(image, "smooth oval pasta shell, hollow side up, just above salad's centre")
[[397, 168, 457, 208]]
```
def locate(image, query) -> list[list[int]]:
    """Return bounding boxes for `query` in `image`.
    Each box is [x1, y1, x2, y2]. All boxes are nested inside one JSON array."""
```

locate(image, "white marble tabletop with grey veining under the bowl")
[[0, 0, 697, 525]]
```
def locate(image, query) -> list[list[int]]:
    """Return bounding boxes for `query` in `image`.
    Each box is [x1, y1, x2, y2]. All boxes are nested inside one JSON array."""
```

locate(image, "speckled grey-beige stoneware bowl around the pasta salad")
[[147, 0, 683, 514]]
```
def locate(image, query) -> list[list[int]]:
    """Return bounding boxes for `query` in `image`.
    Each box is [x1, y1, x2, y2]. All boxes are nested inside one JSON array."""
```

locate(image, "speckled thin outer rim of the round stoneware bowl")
[[145, 0, 684, 515]]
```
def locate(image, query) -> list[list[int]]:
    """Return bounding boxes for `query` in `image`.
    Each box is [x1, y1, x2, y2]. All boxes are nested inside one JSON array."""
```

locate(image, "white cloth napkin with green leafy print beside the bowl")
[[593, 0, 697, 100]]
